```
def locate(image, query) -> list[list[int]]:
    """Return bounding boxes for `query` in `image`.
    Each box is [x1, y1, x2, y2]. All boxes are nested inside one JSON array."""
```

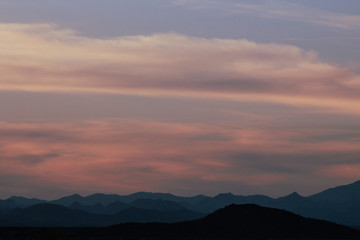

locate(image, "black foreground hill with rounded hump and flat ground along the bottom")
[[0, 204, 360, 240]]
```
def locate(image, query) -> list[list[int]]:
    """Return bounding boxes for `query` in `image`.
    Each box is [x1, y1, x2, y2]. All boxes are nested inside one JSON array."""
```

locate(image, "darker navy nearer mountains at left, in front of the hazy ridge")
[[0, 203, 204, 227]]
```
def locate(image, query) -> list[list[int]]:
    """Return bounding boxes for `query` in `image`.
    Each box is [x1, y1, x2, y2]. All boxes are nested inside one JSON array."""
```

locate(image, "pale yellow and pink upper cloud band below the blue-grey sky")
[[0, 24, 360, 114]]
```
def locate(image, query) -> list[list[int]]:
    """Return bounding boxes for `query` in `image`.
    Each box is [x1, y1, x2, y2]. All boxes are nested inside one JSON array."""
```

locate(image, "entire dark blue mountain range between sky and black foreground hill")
[[0, 181, 360, 226]]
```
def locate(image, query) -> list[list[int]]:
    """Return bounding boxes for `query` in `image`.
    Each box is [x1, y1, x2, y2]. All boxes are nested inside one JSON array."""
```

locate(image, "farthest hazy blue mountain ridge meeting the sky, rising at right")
[[0, 181, 360, 226]]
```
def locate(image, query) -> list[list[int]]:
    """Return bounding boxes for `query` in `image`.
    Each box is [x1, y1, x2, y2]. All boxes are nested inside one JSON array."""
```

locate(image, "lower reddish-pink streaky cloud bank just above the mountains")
[[0, 119, 360, 197]]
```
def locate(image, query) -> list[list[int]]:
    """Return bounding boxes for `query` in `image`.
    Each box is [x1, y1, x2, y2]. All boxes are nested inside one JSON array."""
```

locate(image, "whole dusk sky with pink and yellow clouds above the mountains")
[[0, 0, 360, 199]]
